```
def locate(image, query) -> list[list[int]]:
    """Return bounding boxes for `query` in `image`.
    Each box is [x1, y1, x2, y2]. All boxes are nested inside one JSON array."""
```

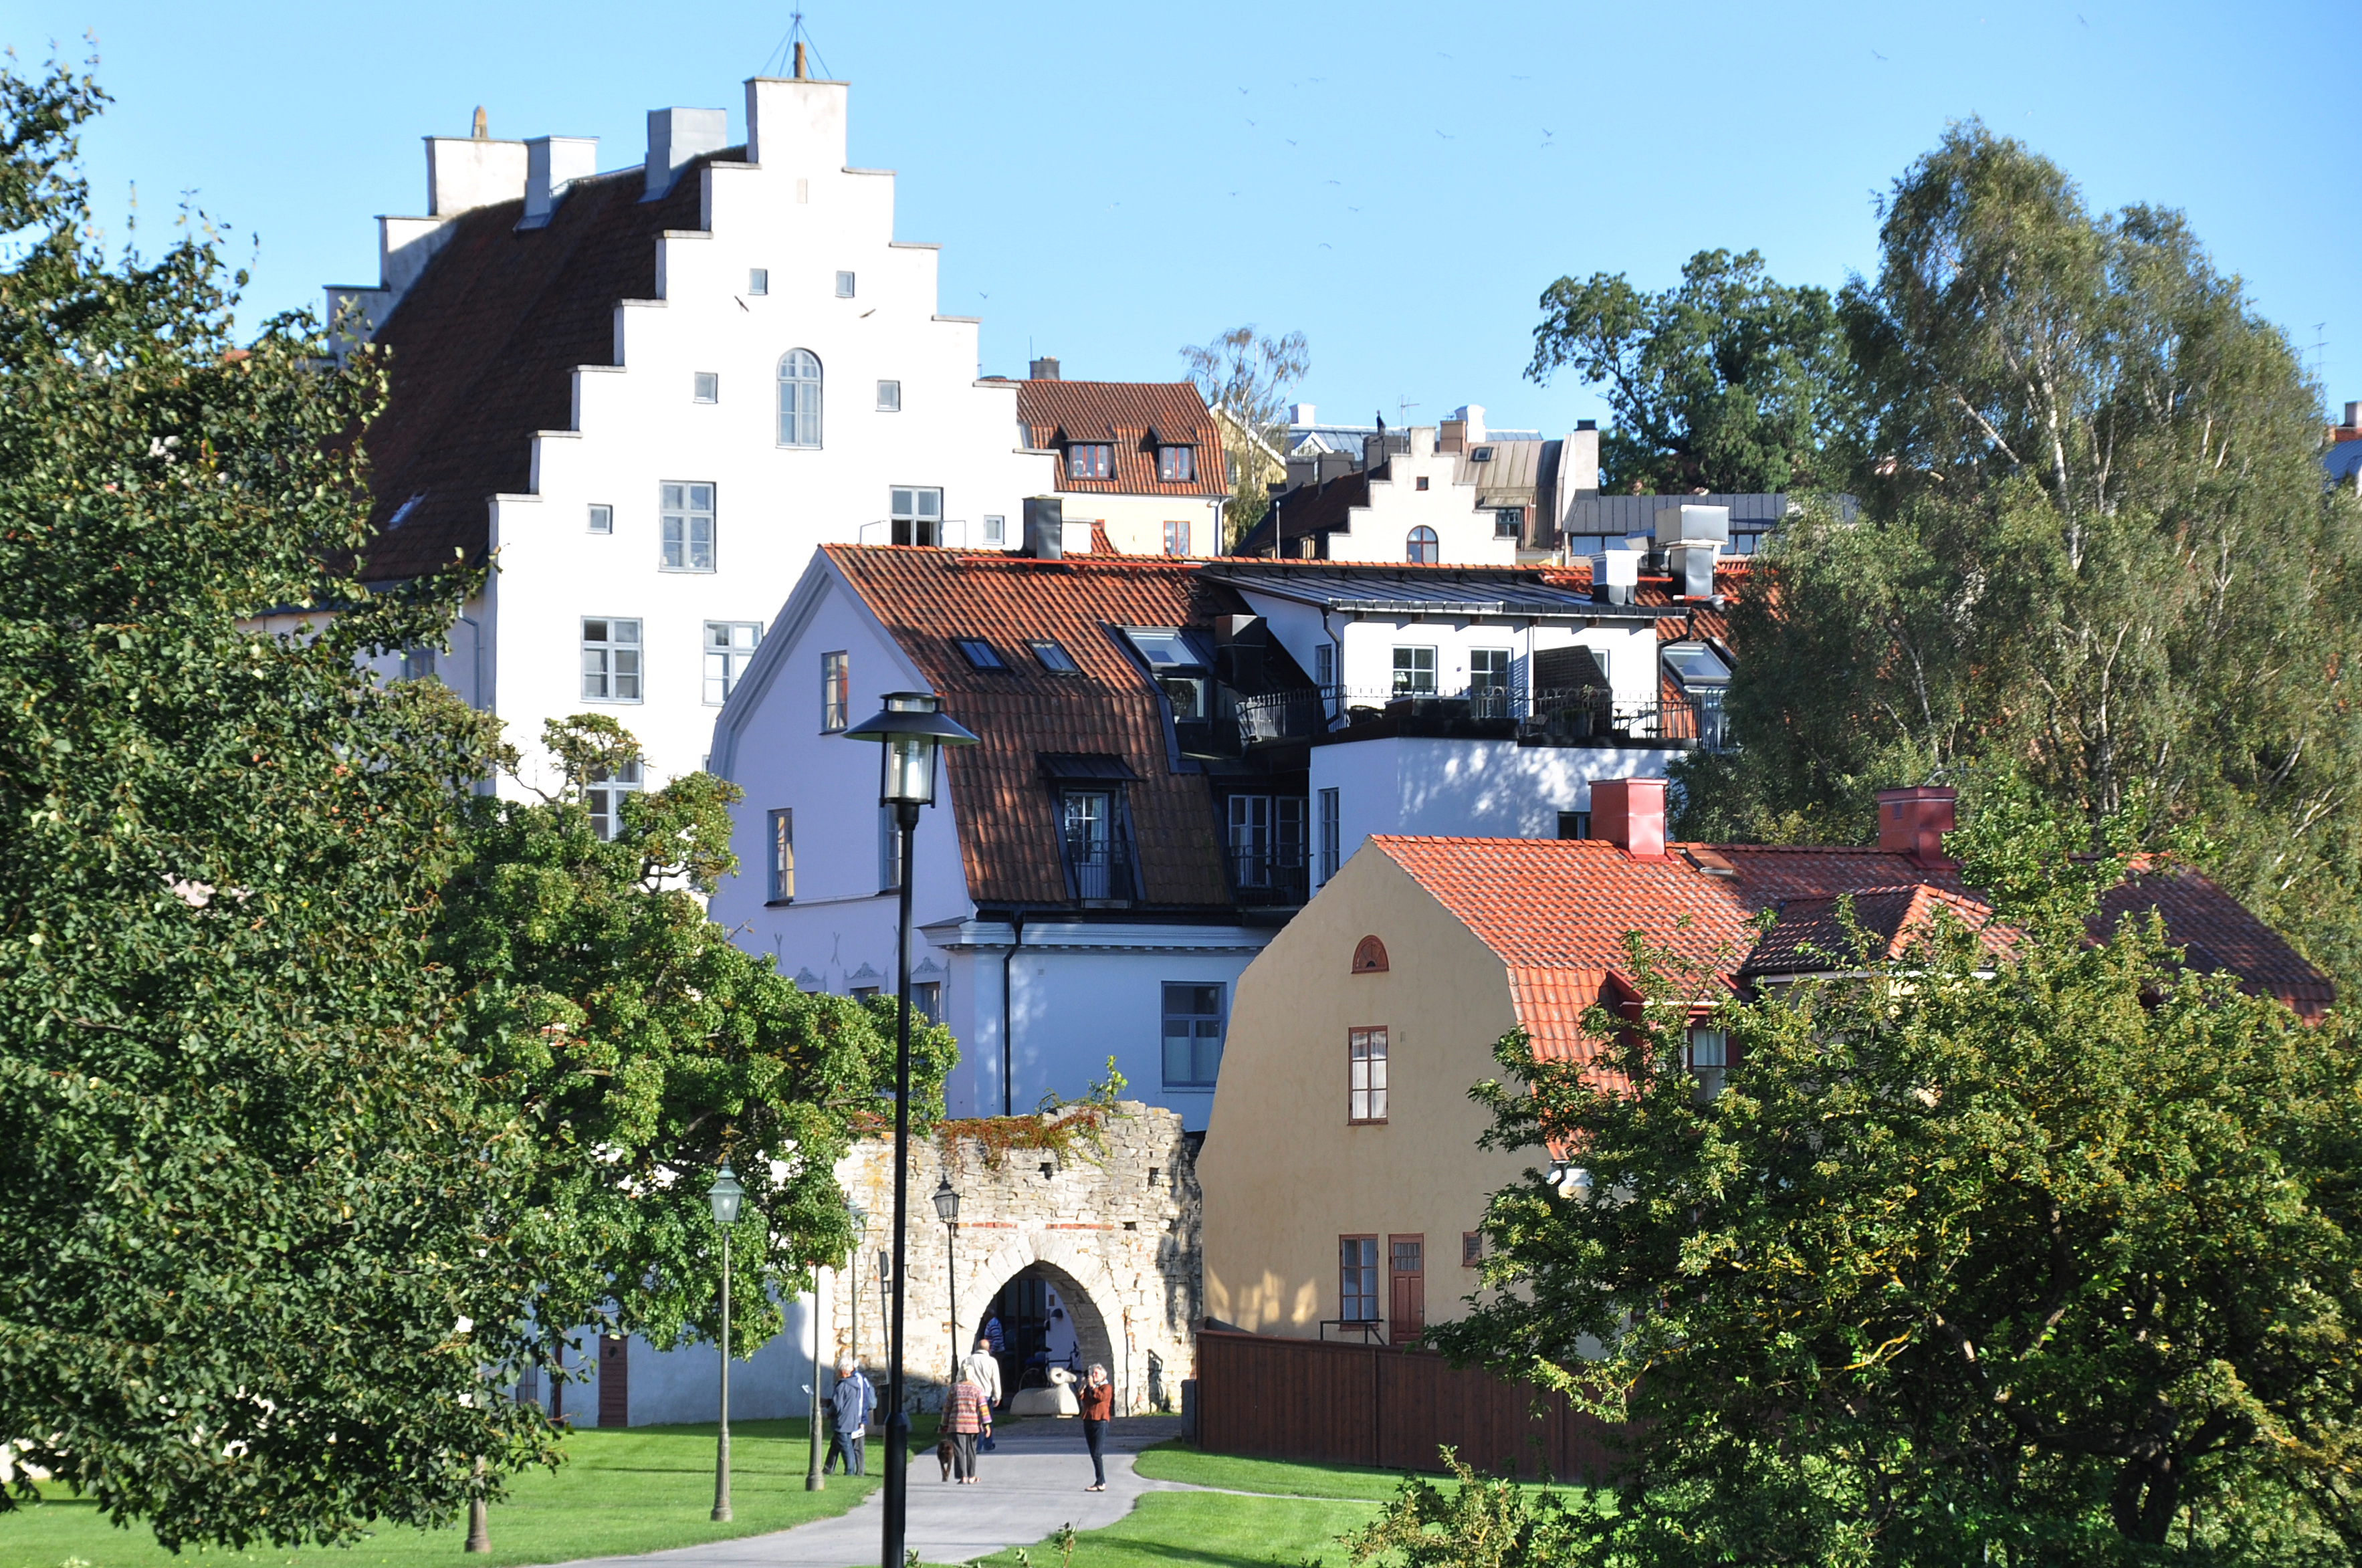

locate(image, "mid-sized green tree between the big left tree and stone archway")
[[435, 715, 954, 1363]]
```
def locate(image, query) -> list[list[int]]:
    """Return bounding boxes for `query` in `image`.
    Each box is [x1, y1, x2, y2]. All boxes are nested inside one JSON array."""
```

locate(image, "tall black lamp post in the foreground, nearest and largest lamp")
[[845, 692, 976, 1568]]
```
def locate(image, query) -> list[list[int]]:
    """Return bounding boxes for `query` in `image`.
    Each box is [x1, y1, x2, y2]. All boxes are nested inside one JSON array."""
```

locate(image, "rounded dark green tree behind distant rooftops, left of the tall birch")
[[1526, 250, 1847, 493]]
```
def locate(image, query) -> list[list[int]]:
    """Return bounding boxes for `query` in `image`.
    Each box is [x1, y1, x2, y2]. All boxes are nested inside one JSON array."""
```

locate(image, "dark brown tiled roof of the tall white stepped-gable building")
[[342, 159, 708, 581]]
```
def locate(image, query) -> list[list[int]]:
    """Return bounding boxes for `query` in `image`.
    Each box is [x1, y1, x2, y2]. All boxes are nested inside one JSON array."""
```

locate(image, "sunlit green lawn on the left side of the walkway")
[[0, 1420, 878, 1568]]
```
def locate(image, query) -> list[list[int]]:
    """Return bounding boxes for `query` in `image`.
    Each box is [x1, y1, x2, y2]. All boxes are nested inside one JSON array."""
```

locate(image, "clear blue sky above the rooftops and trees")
[[18, 0, 2362, 430]]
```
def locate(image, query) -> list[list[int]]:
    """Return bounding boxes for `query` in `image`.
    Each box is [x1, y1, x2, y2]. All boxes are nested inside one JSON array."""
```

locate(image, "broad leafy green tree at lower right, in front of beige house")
[[1429, 796, 2362, 1565]]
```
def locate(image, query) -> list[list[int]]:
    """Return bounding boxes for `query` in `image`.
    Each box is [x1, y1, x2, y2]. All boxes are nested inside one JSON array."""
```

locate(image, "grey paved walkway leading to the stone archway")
[[552, 1417, 1204, 1568]]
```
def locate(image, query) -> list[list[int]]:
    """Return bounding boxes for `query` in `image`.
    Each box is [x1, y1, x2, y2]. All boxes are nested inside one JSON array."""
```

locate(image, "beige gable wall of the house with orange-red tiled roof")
[[1198, 848, 1535, 1339]]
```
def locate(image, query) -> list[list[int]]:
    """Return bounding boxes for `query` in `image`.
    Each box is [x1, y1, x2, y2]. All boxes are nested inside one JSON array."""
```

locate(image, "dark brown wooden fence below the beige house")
[[1198, 1329, 1611, 1480]]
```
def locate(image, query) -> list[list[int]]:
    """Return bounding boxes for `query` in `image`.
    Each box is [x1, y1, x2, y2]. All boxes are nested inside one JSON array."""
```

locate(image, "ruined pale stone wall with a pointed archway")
[[822, 1101, 1204, 1414]]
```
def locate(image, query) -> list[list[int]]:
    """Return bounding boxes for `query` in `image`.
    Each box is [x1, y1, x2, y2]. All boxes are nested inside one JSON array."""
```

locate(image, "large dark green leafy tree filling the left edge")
[[0, 66, 552, 1547]]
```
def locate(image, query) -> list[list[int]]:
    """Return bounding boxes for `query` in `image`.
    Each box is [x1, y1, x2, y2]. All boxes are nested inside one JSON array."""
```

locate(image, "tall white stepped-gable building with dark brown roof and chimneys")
[[328, 78, 1053, 789]]
